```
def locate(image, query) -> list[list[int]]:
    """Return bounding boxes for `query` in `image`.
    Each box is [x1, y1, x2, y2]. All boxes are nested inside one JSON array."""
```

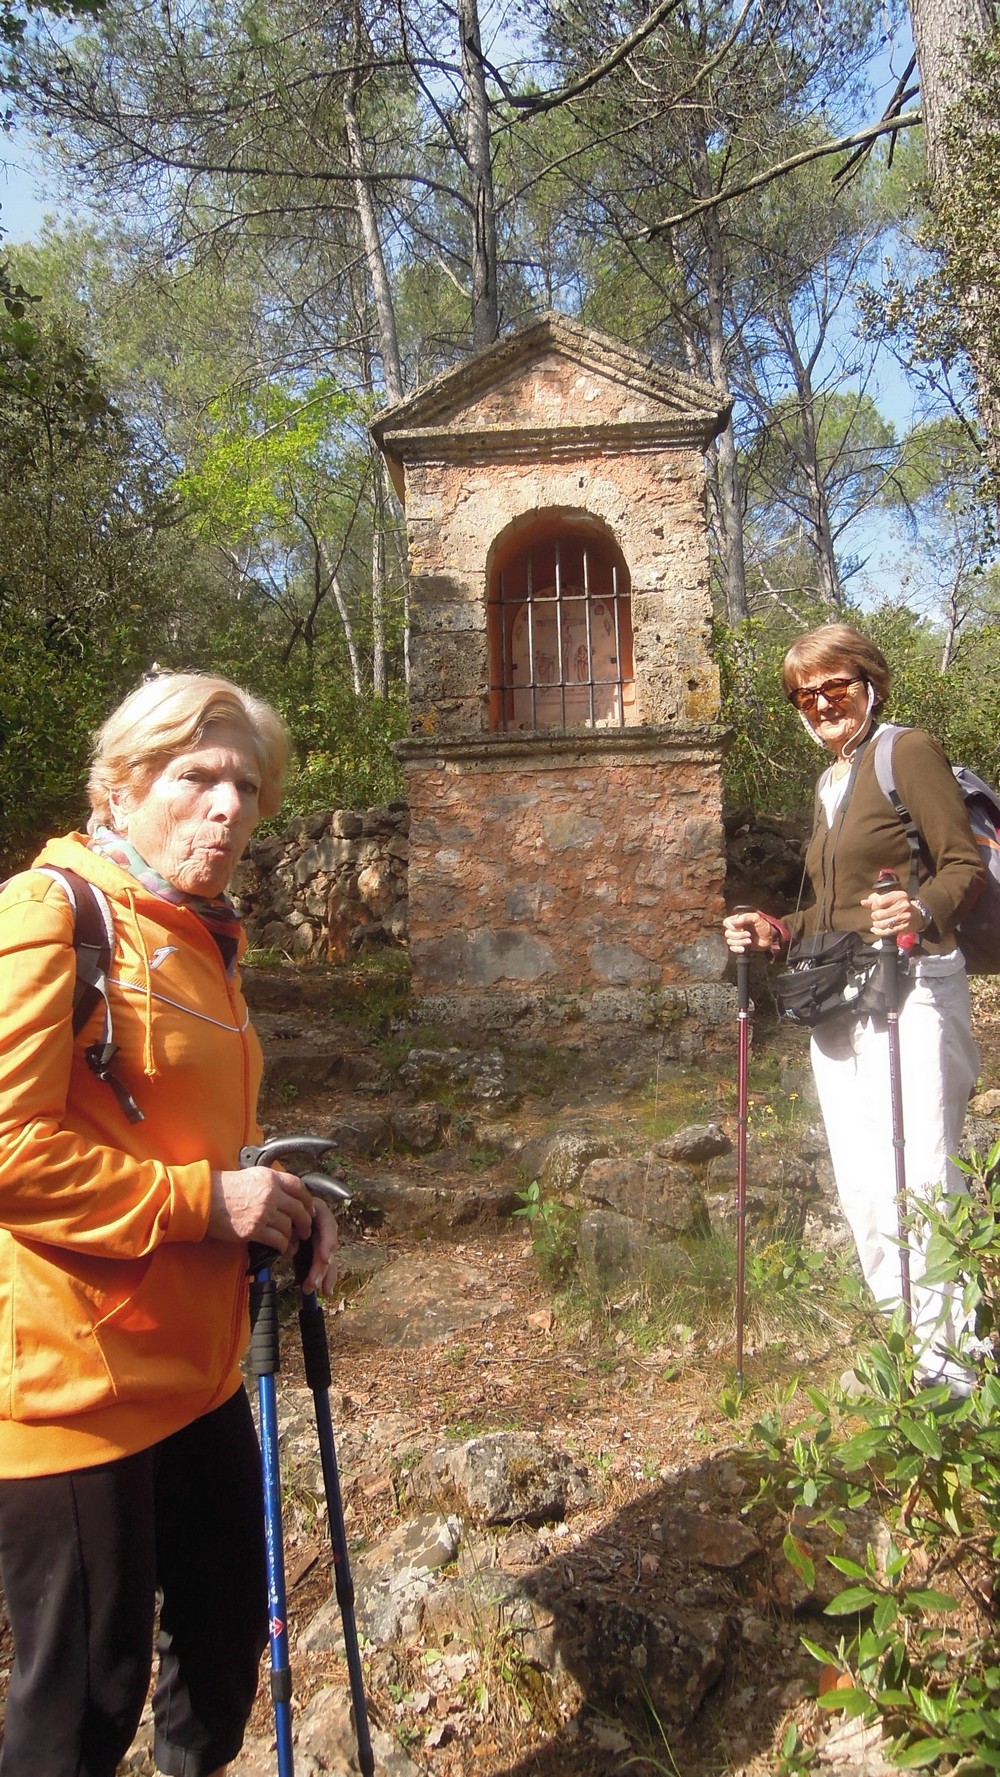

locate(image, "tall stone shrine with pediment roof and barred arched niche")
[[371, 315, 730, 1041]]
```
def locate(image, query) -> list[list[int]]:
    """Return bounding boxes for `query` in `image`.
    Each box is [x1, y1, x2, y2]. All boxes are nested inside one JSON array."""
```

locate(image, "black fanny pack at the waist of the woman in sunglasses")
[[774, 931, 909, 1031]]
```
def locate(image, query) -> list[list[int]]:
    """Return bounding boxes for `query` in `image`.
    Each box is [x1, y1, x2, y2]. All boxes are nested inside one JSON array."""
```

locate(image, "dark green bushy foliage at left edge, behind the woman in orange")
[[0, 316, 196, 869]]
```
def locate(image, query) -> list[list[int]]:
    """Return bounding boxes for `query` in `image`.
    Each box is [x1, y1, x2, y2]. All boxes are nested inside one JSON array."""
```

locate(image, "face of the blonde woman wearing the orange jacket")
[[110, 721, 261, 896]]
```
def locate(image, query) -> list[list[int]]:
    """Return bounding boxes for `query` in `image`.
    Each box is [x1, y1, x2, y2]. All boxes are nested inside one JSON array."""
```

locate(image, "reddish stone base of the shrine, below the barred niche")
[[400, 730, 726, 993]]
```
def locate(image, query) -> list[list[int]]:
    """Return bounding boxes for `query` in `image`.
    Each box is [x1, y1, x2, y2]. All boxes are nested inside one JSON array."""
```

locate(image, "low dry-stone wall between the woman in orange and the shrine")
[[233, 801, 410, 963]]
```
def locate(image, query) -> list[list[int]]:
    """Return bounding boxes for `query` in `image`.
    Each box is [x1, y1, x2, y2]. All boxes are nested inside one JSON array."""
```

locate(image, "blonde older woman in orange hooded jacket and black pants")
[[0, 673, 336, 1777]]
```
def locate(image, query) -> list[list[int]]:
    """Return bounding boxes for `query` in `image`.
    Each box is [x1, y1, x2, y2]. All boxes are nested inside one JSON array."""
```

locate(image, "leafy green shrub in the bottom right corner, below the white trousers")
[[755, 1143, 1000, 1777]]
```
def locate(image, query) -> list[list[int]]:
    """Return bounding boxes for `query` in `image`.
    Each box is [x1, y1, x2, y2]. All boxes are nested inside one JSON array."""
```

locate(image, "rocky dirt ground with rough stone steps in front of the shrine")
[[7, 972, 1000, 1777]]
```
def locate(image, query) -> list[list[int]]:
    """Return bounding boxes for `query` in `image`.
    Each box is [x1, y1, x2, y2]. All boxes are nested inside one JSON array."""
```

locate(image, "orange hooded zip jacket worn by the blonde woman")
[[0, 833, 261, 1477]]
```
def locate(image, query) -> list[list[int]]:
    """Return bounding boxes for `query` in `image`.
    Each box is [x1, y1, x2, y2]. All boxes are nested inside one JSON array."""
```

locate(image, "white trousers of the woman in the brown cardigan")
[[812, 951, 979, 1375]]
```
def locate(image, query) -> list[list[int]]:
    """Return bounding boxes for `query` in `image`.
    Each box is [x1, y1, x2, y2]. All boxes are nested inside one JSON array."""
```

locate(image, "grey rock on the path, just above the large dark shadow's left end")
[[410, 1432, 593, 1525]]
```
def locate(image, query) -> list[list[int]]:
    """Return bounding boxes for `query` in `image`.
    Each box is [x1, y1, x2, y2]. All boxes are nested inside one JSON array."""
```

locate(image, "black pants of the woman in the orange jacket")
[[0, 1390, 266, 1777]]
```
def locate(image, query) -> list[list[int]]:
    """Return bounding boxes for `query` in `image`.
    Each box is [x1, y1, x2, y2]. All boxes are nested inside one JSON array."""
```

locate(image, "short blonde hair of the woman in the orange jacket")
[[87, 672, 291, 830]]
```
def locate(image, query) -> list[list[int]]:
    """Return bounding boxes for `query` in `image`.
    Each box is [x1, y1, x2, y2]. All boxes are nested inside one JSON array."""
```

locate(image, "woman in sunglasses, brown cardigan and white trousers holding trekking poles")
[[725, 624, 982, 1390]]
